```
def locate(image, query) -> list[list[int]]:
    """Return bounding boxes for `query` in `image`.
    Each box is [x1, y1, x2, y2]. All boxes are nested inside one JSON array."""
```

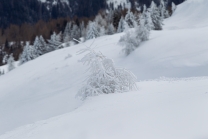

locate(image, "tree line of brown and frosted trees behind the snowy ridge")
[[0, 0, 176, 68]]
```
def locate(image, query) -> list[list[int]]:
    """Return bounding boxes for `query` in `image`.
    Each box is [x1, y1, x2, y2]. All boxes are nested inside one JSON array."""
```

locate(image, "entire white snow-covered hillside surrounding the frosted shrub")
[[0, 0, 208, 139]]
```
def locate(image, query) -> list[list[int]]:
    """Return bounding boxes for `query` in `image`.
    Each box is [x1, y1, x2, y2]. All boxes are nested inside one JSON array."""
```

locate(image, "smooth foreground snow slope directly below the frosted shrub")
[[0, 77, 208, 139]]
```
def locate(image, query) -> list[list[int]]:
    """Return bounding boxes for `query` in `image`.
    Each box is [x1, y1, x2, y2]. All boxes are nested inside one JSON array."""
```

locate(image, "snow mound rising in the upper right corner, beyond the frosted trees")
[[165, 0, 208, 29]]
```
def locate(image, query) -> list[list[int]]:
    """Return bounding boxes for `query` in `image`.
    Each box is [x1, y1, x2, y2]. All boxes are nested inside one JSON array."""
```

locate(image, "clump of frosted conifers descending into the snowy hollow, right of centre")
[[119, 0, 173, 55]]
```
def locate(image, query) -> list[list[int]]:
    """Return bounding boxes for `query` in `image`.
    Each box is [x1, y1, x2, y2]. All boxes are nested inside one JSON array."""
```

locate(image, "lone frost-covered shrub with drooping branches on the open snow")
[[78, 48, 136, 99]]
